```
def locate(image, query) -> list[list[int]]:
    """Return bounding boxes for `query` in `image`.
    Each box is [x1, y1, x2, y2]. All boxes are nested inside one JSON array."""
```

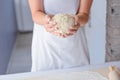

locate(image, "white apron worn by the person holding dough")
[[31, 0, 89, 71]]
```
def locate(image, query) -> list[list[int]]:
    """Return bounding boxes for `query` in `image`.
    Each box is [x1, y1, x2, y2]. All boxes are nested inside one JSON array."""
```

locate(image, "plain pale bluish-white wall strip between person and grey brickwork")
[[86, 0, 106, 64]]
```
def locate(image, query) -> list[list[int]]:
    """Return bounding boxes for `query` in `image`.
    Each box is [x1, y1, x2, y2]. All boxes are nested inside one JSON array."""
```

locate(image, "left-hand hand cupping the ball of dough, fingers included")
[[44, 15, 63, 37]]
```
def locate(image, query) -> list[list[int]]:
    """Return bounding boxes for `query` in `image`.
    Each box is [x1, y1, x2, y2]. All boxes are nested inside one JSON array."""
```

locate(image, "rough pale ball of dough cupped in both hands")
[[52, 14, 74, 34]]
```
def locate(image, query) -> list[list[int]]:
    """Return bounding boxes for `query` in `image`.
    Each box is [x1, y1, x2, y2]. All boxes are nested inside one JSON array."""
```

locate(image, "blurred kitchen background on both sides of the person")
[[0, 0, 120, 74]]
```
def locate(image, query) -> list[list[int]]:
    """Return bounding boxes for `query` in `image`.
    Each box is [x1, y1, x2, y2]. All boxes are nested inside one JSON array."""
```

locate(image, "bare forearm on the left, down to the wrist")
[[28, 0, 45, 25]]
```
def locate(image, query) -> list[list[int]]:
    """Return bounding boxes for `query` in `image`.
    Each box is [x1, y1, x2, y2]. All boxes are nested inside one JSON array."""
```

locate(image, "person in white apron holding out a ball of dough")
[[29, 0, 92, 71]]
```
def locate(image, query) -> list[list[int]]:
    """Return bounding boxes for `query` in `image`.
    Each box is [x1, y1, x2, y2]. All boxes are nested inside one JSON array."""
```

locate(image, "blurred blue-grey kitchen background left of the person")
[[0, 0, 33, 74]]
